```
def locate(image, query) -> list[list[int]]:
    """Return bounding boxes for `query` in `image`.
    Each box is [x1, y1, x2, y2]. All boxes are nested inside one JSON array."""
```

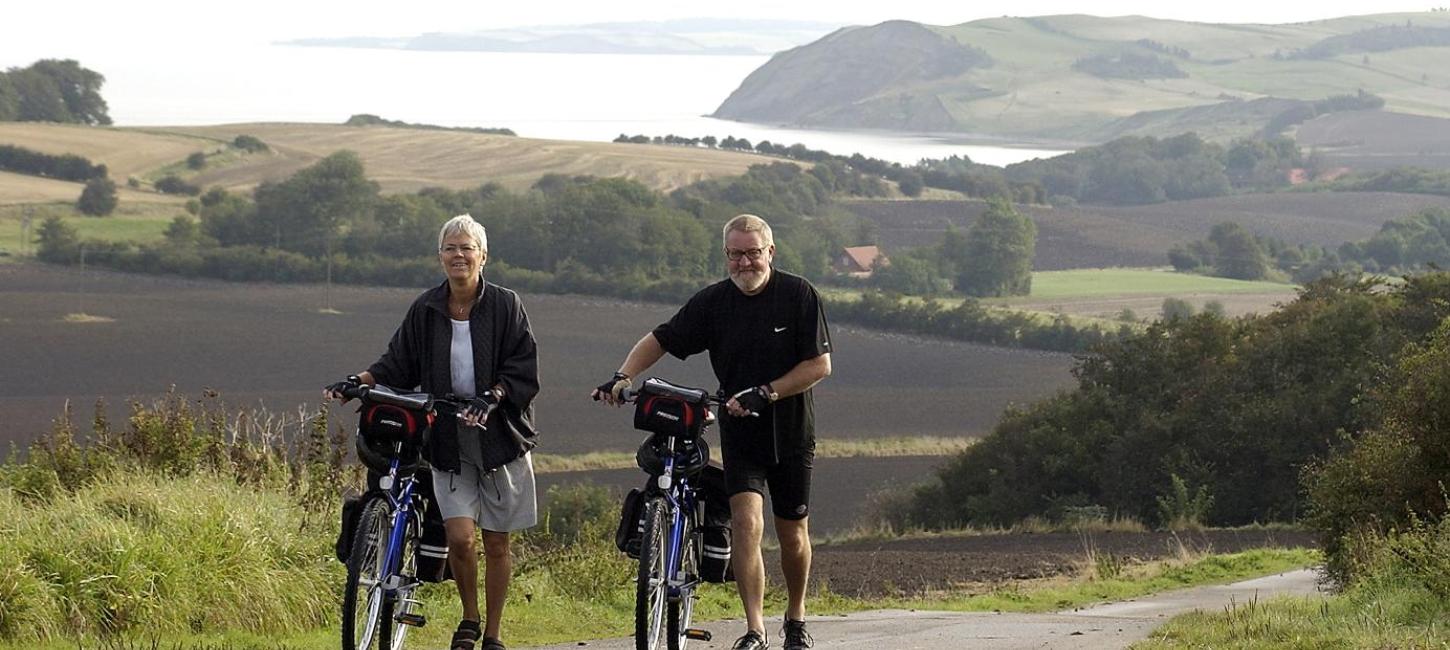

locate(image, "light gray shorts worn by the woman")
[[434, 454, 539, 532]]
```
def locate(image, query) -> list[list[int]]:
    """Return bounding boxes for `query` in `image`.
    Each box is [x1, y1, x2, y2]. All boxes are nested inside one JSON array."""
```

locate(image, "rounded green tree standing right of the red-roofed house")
[[957, 199, 1037, 296]]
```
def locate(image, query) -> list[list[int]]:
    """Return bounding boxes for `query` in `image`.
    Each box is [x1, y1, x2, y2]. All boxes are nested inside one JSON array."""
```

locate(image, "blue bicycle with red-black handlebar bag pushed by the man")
[[621, 377, 729, 650]]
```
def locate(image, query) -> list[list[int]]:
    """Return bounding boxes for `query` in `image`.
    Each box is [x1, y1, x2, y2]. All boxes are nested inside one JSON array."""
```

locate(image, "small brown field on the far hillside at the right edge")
[[1293, 110, 1450, 171]]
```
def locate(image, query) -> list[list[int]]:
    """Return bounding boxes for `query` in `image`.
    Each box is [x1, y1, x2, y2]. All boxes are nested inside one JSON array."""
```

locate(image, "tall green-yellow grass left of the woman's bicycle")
[[0, 393, 361, 643]]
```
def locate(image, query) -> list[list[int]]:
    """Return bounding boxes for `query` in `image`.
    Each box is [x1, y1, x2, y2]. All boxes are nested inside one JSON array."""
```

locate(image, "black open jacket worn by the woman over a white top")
[[368, 280, 539, 473]]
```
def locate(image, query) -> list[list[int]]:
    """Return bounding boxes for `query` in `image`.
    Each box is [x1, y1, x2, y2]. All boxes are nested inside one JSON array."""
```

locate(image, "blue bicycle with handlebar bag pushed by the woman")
[[342, 386, 463, 650]]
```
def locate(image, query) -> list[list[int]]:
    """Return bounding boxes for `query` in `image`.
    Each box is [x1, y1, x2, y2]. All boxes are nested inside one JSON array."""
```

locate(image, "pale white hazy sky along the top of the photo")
[[0, 0, 1432, 65]]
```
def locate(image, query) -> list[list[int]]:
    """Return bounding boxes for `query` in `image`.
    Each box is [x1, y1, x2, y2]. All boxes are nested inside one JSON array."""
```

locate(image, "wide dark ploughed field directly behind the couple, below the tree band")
[[0, 263, 1073, 454]]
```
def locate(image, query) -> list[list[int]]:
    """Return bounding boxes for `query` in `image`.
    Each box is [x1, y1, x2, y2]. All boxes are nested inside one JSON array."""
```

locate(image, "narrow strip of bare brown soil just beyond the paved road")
[[800, 530, 1315, 598]]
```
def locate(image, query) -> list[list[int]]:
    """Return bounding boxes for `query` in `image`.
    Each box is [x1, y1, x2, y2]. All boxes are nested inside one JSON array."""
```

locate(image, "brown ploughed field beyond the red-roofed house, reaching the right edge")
[[844, 192, 1450, 270]]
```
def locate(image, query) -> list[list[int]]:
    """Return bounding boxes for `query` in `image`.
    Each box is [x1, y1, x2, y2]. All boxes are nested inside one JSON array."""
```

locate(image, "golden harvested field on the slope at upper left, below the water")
[[0, 122, 767, 197]]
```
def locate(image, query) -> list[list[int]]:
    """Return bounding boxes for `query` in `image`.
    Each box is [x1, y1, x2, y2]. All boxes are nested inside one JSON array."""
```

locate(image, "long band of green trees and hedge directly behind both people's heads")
[[38, 152, 1118, 351]]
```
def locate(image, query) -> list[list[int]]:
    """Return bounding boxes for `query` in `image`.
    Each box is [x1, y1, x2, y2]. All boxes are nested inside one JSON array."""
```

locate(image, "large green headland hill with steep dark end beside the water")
[[715, 12, 1450, 142]]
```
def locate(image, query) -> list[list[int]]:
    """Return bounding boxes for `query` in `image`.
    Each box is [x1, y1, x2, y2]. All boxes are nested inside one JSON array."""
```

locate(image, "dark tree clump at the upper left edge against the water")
[[0, 58, 110, 125]]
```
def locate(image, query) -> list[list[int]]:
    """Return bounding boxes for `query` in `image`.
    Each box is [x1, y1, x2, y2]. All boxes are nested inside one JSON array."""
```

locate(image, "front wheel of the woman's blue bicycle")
[[342, 498, 393, 650]]
